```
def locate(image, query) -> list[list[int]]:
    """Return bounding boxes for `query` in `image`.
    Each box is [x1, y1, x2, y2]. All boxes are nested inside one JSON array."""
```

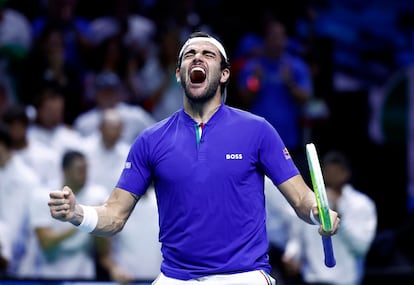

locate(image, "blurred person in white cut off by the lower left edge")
[[0, 124, 40, 278]]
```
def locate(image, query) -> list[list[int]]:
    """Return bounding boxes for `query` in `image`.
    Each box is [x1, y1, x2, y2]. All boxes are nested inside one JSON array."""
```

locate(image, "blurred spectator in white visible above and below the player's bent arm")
[[80, 109, 161, 283]]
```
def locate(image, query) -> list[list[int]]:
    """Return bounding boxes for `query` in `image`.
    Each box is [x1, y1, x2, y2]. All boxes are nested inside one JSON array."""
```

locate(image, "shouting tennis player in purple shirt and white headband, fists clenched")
[[48, 32, 339, 285]]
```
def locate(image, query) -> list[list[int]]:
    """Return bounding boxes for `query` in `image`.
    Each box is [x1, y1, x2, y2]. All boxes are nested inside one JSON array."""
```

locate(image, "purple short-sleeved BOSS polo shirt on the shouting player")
[[117, 105, 299, 280]]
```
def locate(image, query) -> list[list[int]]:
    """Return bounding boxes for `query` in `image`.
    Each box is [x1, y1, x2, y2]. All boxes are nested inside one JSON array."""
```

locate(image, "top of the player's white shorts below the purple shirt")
[[152, 270, 276, 285]]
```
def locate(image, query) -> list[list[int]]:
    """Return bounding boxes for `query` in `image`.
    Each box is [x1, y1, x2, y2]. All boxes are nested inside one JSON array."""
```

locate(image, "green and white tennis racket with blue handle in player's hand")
[[306, 143, 336, 267]]
